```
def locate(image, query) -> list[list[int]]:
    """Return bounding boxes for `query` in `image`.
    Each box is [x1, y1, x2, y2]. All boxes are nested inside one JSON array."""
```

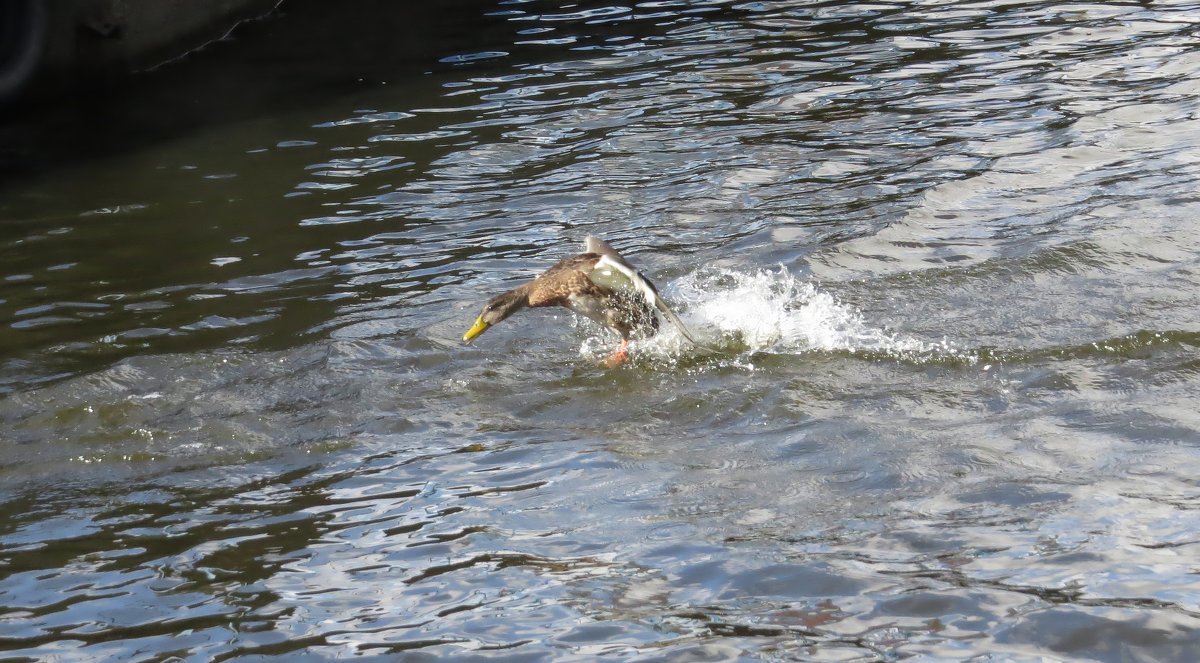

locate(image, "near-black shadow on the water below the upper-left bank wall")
[[0, 0, 512, 181]]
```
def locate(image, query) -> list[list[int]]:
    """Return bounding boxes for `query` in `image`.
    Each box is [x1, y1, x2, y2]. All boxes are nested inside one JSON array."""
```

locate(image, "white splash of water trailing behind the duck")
[[581, 267, 958, 360]]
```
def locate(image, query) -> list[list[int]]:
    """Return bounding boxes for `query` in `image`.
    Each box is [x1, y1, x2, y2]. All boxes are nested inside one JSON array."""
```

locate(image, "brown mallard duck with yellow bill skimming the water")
[[462, 237, 696, 366]]
